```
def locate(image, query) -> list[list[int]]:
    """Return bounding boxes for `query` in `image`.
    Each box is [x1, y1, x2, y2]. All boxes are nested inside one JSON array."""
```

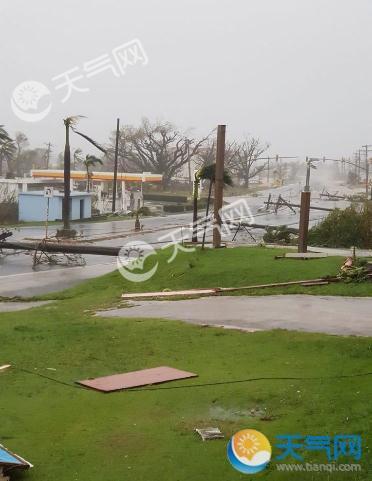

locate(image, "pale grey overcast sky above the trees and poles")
[[0, 0, 372, 161]]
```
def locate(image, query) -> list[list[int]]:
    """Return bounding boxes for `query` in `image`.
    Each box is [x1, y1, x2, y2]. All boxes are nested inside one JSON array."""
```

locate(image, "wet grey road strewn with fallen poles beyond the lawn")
[[0, 184, 360, 296]]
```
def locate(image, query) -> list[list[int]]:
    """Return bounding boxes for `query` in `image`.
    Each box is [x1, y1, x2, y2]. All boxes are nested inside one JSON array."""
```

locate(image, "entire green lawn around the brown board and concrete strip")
[[0, 248, 372, 481]]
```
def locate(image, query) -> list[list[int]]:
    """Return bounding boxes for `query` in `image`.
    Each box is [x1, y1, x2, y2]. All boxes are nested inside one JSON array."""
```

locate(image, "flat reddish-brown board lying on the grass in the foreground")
[[77, 366, 197, 392]]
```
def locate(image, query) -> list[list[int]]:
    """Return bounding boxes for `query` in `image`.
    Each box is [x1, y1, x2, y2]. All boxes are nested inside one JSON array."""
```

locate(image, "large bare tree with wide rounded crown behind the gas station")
[[130, 119, 208, 187]]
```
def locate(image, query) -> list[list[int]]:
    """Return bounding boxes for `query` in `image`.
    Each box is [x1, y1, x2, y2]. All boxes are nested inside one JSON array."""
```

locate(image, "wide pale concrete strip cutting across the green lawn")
[[97, 295, 372, 336]]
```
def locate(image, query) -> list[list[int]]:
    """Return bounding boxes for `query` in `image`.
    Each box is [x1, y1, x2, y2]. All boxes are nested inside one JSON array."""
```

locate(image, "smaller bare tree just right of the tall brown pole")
[[232, 137, 269, 187]]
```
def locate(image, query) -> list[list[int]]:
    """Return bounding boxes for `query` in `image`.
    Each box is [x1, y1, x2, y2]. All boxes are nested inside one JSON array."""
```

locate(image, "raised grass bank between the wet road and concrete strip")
[[43, 247, 372, 300]]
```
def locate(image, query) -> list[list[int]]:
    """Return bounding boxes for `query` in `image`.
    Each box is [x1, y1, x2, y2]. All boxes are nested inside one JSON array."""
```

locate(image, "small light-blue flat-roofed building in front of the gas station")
[[18, 191, 92, 222]]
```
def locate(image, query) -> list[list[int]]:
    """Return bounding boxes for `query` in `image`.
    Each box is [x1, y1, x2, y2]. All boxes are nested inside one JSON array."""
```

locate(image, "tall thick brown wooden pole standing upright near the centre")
[[213, 125, 226, 248]]
